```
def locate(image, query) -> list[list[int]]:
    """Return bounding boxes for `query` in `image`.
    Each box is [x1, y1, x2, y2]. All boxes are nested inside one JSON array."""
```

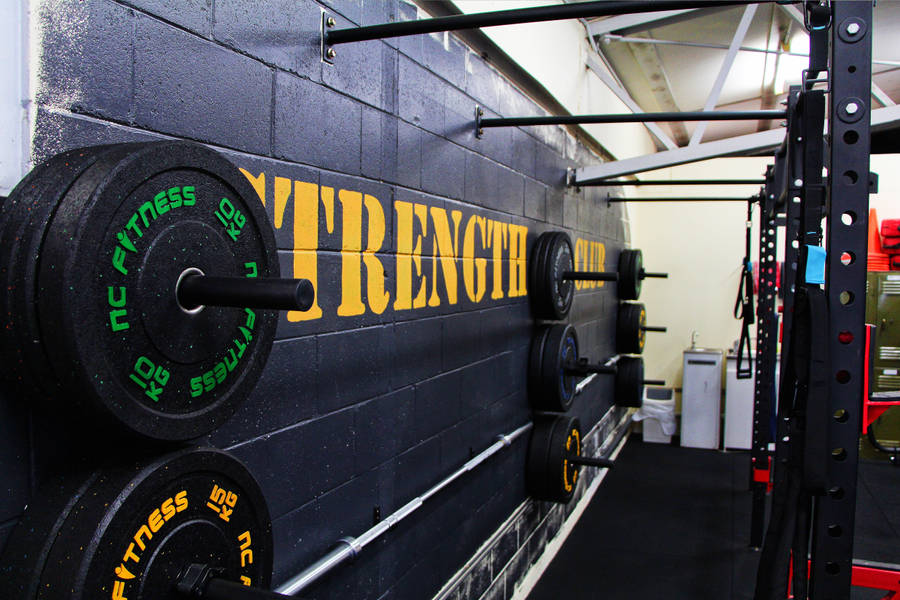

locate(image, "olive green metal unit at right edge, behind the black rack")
[[862, 271, 900, 458]]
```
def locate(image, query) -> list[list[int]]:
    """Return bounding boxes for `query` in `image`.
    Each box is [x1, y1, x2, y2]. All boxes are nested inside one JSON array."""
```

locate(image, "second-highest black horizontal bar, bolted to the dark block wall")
[[477, 110, 787, 128]]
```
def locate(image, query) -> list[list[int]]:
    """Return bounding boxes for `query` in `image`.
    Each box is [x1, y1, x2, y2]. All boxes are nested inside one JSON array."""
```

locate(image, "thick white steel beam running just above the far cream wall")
[[573, 104, 900, 185]]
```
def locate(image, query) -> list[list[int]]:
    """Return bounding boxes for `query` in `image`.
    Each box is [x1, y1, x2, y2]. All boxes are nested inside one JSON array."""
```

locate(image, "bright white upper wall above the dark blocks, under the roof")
[[454, 0, 656, 159]]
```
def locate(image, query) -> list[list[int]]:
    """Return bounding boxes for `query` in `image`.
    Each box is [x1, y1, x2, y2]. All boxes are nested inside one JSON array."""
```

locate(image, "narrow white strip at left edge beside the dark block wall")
[[0, 0, 31, 196]]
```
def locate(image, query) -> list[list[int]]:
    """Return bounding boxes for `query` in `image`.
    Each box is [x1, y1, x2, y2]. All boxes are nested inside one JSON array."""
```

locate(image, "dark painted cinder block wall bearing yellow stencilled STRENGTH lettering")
[[0, 0, 626, 599]]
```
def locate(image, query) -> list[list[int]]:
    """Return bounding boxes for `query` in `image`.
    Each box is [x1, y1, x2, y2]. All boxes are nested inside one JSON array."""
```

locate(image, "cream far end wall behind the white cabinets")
[[627, 158, 772, 387]]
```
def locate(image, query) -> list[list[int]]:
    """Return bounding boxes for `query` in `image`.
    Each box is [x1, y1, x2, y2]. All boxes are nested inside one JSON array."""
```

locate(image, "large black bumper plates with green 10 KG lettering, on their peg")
[[0, 142, 314, 440]]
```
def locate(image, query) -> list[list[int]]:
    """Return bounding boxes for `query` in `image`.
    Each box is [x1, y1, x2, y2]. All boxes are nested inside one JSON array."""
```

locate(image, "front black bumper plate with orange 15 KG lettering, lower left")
[[35, 449, 273, 600]]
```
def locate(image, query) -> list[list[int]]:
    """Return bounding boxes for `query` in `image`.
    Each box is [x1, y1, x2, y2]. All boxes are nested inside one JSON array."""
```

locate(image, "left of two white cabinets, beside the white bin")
[[681, 350, 722, 449]]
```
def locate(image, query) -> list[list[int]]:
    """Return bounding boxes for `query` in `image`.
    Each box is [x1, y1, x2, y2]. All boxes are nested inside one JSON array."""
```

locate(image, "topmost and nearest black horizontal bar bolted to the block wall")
[[325, 0, 774, 46]]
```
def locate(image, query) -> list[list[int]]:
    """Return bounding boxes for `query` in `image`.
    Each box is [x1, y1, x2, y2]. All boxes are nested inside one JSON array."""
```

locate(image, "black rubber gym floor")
[[528, 435, 900, 600]]
